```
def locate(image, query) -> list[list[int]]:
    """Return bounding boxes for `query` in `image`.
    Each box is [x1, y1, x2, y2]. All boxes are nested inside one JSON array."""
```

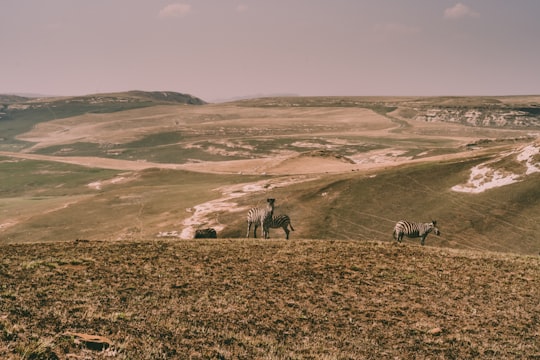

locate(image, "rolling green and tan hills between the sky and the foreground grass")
[[0, 92, 540, 254]]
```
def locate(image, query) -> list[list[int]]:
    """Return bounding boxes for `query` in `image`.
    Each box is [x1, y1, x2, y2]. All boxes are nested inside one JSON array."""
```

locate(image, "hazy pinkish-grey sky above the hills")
[[0, 0, 540, 101]]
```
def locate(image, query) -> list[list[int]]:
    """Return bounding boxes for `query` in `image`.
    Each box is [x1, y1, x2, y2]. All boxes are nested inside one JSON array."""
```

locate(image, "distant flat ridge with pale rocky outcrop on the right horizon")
[[236, 95, 540, 129]]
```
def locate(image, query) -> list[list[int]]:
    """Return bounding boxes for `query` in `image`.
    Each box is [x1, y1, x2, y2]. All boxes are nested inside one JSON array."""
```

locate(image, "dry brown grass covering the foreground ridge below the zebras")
[[0, 239, 540, 359]]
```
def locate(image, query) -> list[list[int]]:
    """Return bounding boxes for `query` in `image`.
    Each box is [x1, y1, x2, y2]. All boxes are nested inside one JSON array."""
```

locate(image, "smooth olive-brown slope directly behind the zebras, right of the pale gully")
[[222, 158, 540, 254]]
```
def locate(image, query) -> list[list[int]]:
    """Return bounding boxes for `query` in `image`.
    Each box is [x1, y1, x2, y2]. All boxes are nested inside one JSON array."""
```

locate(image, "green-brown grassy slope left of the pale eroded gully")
[[0, 158, 253, 243]]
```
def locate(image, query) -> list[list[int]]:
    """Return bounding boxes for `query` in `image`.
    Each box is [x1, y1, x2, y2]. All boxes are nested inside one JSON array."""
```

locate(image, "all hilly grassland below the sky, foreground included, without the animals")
[[0, 92, 540, 359]]
